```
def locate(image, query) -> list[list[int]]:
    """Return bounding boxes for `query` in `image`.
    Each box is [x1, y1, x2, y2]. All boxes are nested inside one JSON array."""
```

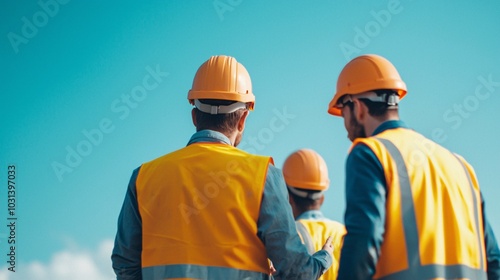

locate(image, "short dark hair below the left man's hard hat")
[[194, 99, 244, 133]]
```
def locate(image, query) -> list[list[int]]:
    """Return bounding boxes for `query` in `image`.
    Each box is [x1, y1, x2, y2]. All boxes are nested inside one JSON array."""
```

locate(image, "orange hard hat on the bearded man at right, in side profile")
[[328, 54, 406, 116]]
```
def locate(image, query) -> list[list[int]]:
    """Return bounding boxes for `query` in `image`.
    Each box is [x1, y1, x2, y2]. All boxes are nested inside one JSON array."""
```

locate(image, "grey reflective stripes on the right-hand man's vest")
[[376, 137, 486, 280]]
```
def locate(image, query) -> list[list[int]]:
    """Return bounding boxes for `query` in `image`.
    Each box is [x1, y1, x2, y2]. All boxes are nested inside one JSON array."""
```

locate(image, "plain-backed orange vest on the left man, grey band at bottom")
[[136, 143, 272, 279]]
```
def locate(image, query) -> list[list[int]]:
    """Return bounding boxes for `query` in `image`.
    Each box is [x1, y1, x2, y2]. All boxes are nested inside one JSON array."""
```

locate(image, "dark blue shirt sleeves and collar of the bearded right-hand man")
[[337, 120, 500, 280]]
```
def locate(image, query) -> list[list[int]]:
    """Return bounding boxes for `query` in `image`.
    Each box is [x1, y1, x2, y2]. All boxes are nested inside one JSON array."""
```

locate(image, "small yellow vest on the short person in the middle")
[[296, 218, 345, 280]]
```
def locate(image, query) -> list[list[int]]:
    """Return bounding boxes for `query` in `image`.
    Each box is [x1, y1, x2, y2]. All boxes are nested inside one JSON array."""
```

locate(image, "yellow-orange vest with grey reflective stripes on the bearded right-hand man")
[[353, 128, 486, 280]]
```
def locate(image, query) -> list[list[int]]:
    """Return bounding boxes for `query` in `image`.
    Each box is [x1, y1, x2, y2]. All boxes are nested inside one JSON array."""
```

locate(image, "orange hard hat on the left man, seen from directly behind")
[[188, 55, 255, 114]]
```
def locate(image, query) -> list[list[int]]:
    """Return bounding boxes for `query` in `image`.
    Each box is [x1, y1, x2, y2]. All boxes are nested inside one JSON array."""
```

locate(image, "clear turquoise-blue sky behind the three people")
[[0, 0, 500, 279]]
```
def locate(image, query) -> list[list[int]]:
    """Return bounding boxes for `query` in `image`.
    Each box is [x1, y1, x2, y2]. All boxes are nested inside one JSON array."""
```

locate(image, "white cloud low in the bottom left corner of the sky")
[[0, 240, 116, 280]]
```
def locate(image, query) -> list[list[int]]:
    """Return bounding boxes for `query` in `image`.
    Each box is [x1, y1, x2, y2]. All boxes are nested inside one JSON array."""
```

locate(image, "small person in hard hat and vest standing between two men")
[[283, 149, 345, 280]]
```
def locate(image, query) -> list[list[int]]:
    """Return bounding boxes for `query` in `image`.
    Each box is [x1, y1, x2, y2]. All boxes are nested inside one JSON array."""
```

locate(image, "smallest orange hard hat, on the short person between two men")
[[283, 149, 330, 191]]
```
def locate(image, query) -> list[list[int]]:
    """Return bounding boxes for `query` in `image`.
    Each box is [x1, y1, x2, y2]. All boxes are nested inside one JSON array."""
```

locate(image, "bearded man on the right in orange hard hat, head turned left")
[[328, 55, 500, 280]]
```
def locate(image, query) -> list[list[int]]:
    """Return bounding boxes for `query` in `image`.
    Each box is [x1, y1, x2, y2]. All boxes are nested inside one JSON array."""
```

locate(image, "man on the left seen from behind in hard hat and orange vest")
[[111, 56, 332, 279]]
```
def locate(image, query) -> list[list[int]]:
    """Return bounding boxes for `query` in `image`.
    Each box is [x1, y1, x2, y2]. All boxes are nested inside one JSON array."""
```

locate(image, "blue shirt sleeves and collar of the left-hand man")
[[111, 130, 332, 280]]
